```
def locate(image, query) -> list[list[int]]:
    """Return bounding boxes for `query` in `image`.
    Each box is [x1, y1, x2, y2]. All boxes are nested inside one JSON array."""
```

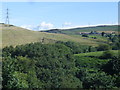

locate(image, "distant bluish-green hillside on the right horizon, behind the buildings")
[[44, 25, 118, 35]]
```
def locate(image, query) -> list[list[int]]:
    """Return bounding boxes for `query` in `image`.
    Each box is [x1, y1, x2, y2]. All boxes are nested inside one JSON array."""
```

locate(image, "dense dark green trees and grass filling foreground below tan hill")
[[2, 42, 120, 89]]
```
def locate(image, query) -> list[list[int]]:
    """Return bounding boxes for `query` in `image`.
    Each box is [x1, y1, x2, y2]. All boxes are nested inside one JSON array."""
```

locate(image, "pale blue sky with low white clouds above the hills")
[[1, 2, 118, 30]]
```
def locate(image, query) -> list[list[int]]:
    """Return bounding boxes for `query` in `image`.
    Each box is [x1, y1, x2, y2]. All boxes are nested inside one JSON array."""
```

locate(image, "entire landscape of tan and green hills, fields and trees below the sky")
[[0, 25, 120, 89]]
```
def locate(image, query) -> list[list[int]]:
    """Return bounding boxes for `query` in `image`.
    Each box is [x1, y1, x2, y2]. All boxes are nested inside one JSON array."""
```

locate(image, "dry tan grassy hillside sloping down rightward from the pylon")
[[0, 24, 101, 47]]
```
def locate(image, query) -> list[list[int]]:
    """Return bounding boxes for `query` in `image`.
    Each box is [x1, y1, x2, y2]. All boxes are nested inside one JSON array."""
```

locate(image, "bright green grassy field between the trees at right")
[[74, 50, 118, 69]]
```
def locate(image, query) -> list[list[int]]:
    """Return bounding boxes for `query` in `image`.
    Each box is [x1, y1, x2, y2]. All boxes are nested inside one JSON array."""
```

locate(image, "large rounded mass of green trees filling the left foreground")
[[3, 43, 82, 88]]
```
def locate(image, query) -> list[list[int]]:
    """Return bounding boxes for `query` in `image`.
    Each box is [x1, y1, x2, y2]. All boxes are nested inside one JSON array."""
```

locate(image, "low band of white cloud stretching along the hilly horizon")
[[20, 22, 118, 31]]
